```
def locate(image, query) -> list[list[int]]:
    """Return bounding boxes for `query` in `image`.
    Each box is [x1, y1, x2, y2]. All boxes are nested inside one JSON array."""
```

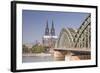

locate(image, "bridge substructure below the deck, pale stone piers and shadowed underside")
[[53, 49, 91, 61]]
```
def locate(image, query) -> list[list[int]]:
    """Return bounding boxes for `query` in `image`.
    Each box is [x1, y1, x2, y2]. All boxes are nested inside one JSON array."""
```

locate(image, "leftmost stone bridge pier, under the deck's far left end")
[[54, 50, 66, 61]]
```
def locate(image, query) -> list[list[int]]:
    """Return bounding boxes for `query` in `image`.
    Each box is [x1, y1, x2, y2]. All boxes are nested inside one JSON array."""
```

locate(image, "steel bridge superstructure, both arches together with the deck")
[[54, 15, 91, 60]]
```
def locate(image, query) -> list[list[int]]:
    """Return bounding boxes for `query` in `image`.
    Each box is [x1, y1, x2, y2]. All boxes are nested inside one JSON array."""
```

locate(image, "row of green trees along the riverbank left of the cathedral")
[[22, 44, 47, 53]]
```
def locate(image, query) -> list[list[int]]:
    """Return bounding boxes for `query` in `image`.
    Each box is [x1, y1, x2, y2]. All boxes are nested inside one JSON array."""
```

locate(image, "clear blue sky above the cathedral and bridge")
[[22, 10, 89, 43]]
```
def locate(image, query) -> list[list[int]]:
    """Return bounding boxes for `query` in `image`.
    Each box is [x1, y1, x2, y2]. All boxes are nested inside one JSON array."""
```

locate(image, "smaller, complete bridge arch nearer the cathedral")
[[56, 28, 76, 48]]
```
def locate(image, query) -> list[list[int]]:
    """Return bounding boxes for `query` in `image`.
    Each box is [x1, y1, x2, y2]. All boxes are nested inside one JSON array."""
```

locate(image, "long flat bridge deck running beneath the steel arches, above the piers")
[[54, 48, 91, 52]]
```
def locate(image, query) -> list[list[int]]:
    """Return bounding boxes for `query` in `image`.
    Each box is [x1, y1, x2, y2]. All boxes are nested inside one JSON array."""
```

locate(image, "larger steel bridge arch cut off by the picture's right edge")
[[74, 15, 91, 49]]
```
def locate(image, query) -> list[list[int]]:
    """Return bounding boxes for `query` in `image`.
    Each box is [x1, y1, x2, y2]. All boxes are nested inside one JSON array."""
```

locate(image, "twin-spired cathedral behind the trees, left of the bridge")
[[43, 21, 57, 50]]
